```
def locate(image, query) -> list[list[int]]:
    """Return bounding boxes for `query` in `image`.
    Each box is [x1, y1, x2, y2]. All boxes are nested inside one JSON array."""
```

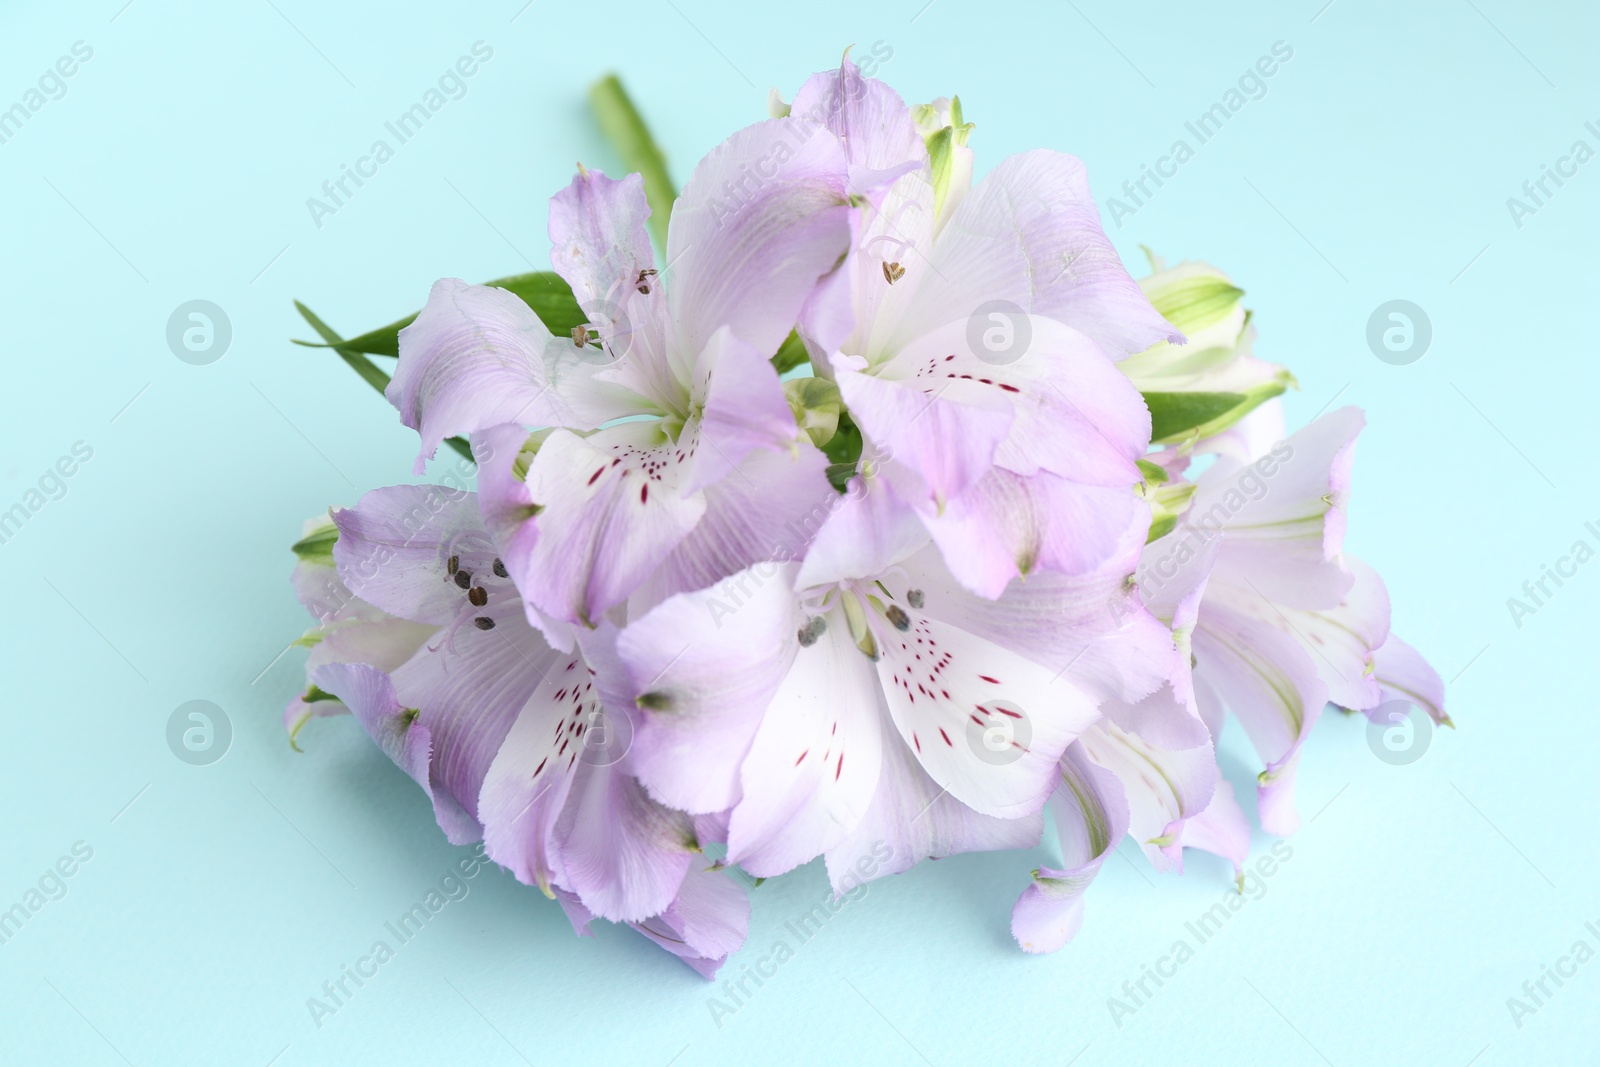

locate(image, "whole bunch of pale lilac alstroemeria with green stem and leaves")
[[286, 59, 1448, 976]]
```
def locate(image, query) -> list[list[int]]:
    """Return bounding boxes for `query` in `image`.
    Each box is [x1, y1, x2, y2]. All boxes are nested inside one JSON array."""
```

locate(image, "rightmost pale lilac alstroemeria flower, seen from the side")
[[1139, 408, 1445, 835]]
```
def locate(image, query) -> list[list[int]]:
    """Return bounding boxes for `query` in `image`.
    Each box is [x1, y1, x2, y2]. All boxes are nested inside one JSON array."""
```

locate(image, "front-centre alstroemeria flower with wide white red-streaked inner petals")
[[618, 501, 1173, 888]]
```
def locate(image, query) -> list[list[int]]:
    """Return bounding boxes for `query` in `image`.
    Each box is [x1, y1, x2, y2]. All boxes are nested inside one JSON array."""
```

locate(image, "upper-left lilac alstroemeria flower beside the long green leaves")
[[389, 118, 851, 640]]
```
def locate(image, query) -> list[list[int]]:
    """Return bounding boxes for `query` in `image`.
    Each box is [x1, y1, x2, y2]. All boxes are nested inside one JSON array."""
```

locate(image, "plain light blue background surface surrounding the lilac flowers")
[[0, 0, 1600, 1067]]
